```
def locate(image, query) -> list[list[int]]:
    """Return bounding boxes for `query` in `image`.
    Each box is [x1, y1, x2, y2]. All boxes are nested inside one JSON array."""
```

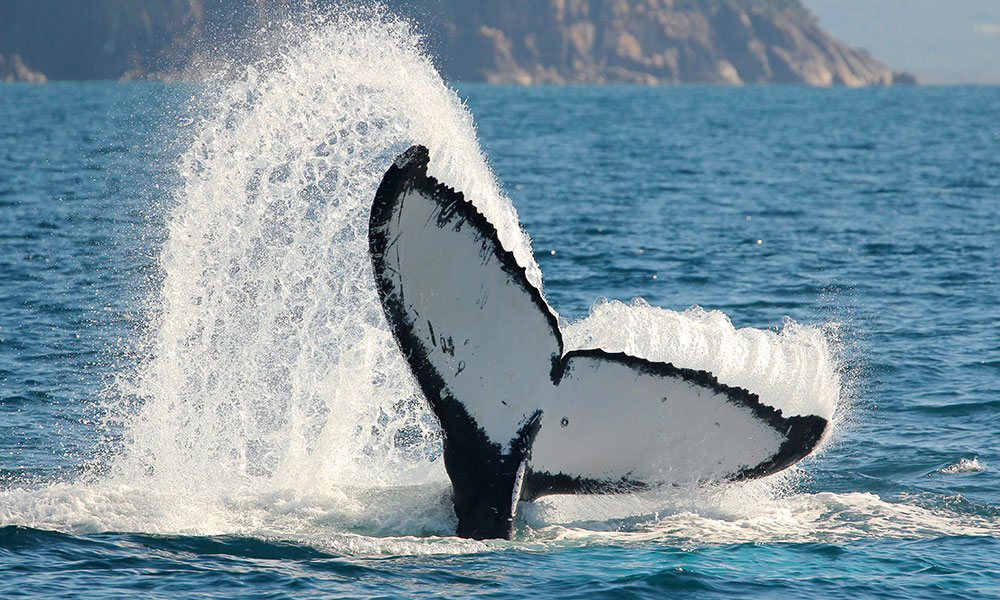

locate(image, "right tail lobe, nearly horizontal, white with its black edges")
[[528, 349, 826, 497]]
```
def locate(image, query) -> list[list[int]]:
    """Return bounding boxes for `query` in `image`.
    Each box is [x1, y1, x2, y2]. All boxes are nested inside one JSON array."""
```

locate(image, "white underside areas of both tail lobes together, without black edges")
[[390, 180, 784, 484]]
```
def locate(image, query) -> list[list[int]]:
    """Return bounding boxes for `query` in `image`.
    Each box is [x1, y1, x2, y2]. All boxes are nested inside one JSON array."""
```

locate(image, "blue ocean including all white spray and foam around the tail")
[[0, 14, 1000, 599]]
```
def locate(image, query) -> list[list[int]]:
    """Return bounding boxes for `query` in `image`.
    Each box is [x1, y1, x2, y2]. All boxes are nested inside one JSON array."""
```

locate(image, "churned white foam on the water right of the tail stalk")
[[525, 484, 998, 547]]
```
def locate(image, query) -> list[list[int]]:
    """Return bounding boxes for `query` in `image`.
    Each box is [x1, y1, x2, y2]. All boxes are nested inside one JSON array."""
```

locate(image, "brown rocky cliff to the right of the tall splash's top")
[[426, 0, 894, 86]]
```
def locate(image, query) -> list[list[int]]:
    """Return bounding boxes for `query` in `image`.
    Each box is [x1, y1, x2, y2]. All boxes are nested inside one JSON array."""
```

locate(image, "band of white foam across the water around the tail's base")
[[0, 484, 1000, 556]]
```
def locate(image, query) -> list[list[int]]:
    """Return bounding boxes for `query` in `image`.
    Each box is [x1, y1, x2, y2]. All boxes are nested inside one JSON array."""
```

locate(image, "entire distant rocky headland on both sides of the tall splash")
[[0, 0, 906, 86]]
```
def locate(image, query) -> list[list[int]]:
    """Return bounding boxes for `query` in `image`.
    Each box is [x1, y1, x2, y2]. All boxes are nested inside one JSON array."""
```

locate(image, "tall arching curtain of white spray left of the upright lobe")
[[112, 16, 537, 506]]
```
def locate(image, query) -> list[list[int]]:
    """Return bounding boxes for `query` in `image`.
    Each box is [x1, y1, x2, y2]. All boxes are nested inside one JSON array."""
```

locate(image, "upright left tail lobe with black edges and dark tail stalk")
[[369, 146, 562, 538]]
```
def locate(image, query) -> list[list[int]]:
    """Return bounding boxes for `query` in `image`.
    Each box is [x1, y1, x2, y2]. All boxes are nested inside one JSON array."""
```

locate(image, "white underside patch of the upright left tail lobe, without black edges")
[[389, 189, 560, 446]]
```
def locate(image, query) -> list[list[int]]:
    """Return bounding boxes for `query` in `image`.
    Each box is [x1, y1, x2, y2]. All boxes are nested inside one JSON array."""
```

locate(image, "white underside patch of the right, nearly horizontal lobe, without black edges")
[[530, 356, 784, 485]]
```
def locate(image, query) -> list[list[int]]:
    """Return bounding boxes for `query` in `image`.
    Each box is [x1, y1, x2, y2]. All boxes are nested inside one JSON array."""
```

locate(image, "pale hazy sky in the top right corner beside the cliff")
[[802, 0, 1000, 84]]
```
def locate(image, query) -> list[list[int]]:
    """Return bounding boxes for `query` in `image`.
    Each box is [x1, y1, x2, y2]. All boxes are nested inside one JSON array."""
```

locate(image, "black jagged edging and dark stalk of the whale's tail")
[[369, 146, 827, 539]]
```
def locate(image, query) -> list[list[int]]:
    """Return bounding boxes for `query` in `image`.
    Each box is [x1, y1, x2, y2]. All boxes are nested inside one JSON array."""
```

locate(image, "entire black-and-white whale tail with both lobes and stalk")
[[369, 146, 827, 539]]
